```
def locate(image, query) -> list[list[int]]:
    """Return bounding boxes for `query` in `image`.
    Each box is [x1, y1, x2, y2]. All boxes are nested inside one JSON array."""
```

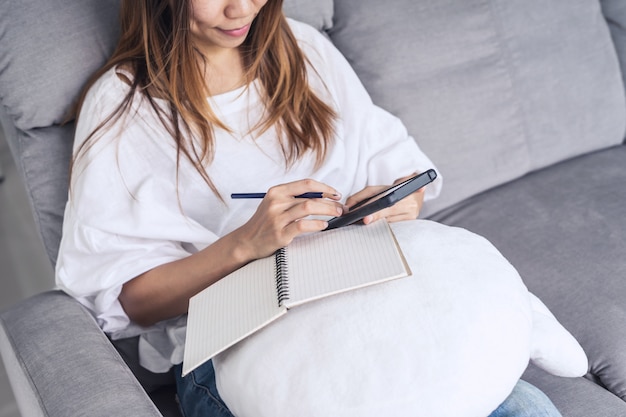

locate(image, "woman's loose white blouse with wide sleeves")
[[56, 20, 441, 372]]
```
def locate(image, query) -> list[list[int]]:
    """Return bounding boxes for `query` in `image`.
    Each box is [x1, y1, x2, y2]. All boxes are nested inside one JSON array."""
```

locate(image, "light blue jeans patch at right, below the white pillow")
[[489, 380, 561, 417]]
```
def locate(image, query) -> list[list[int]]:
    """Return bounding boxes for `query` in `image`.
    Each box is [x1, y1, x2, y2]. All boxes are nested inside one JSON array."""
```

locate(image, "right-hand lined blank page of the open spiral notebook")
[[285, 221, 409, 307]]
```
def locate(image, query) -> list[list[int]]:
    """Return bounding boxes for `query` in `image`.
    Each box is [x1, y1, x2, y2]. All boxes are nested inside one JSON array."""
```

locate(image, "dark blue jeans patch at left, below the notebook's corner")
[[174, 361, 234, 417]]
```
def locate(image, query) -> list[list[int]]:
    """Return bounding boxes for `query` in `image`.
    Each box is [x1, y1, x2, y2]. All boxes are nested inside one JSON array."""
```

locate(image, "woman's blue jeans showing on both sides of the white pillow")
[[174, 361, 561, 417]]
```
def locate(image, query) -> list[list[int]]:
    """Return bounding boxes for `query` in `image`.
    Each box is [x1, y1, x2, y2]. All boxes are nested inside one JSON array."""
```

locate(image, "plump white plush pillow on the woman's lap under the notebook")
[[214, 220, 587, 417]]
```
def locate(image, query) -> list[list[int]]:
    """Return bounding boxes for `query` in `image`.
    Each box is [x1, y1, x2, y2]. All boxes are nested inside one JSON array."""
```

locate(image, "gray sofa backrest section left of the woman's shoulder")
[[0, 0, 119, 263]]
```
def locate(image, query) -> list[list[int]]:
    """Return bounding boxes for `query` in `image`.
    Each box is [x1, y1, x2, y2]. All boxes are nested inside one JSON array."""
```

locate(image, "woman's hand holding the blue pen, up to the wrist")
[[233, 179, 344, 260]]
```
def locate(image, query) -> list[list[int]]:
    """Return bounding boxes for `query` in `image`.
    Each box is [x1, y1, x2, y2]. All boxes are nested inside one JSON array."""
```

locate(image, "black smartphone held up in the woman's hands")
[[324, 169, 437, 230]]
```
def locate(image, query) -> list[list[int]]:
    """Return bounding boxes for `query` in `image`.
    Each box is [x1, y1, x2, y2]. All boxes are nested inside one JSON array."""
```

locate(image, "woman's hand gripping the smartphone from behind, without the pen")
[[346, 174, 424, 224]]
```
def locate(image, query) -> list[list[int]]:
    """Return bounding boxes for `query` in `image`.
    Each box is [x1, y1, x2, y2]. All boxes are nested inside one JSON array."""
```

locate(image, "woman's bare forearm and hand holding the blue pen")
[[119, 180, 343, 326]]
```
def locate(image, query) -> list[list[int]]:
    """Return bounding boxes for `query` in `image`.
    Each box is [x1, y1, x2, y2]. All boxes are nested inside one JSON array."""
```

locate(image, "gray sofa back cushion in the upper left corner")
[[0, 0, 119, 130]]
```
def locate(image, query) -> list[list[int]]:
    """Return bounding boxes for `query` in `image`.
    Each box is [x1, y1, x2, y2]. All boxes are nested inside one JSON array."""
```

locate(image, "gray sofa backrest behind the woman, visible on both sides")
[[0, 0, 626, 263]]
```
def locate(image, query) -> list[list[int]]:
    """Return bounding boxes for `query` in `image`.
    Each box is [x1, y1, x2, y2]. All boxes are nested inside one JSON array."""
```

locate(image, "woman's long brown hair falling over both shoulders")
[[72, 0, 336, 193]]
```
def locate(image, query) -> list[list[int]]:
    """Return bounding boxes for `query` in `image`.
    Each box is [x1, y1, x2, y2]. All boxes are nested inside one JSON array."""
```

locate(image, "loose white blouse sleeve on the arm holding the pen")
[[56, 71, 217, 336]]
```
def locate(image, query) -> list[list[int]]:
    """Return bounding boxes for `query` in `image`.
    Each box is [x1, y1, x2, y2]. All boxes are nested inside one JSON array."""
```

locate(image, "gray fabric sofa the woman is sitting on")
[[0, 0, 626, 417]]
